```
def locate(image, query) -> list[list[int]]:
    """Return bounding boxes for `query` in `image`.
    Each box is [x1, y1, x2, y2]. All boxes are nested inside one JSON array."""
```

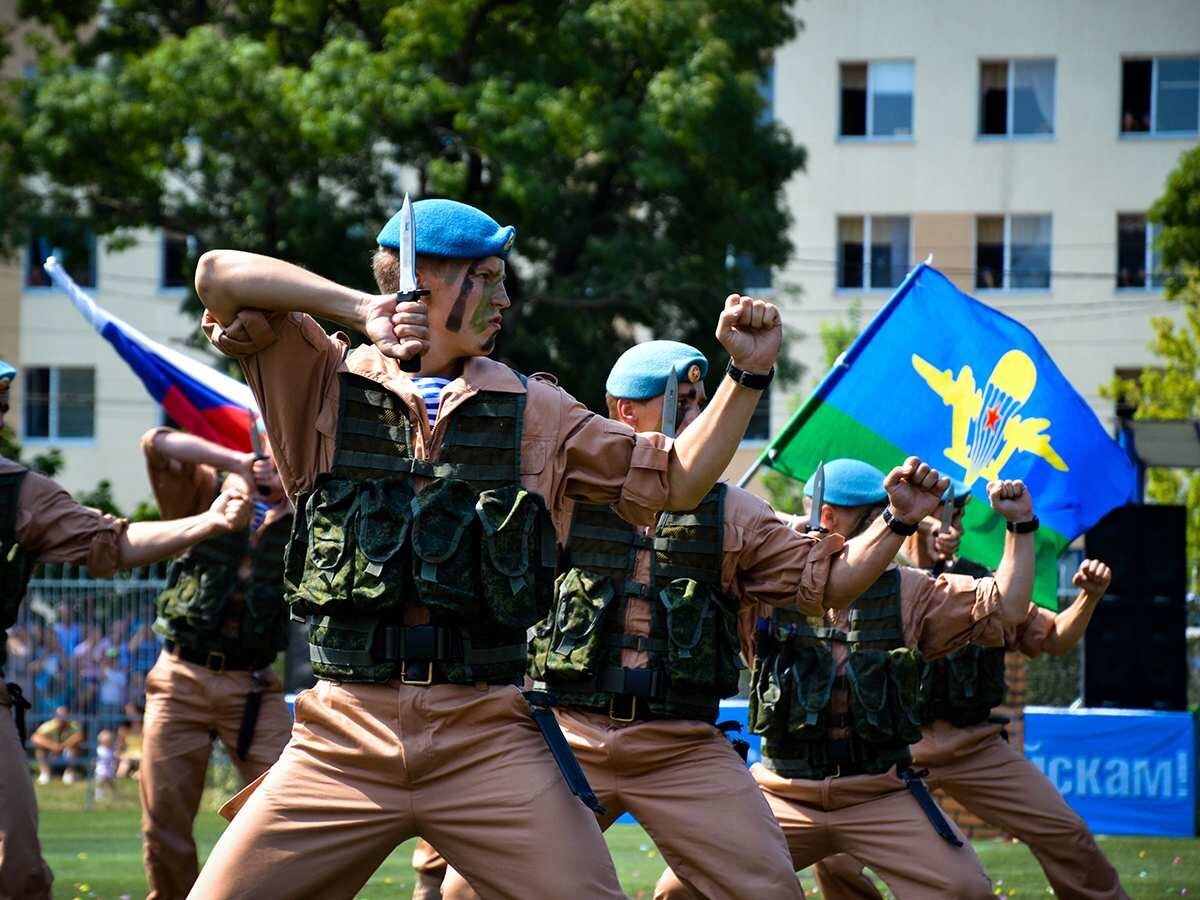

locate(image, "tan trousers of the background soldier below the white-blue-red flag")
[[138, 650, 292, 900]]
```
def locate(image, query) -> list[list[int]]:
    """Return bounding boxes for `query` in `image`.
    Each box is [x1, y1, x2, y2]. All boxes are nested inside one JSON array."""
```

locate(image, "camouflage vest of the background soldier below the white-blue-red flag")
[[154, 515, 292, 668]]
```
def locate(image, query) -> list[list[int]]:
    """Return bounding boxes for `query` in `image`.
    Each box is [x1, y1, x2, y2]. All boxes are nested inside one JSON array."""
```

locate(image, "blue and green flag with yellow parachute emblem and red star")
[[760, 264, 1136, 610]]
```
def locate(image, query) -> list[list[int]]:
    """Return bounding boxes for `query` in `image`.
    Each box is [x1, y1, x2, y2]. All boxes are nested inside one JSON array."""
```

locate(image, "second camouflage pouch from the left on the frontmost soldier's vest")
[[354, 478, 413, 612]]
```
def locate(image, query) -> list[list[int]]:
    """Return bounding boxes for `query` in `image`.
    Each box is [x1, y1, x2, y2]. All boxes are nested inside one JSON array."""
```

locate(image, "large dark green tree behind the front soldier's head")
[[0, 0, 804, 408]]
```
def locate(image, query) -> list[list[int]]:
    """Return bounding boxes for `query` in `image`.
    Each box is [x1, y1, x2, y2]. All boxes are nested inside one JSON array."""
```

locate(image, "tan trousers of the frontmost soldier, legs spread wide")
[[191, 680, 624, 900]]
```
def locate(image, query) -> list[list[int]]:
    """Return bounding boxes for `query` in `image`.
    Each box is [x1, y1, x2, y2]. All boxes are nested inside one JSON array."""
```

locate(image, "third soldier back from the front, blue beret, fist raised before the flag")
[[655, 460, 1037, 898]]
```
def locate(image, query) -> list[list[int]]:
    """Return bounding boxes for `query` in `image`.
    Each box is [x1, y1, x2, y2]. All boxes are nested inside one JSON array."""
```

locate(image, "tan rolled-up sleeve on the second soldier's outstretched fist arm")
[[721, 487, 846, 616]]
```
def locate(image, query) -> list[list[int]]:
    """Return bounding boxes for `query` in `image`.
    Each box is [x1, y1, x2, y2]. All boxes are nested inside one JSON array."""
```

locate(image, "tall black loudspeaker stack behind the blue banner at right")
[[1082, 505, 1188, 710]]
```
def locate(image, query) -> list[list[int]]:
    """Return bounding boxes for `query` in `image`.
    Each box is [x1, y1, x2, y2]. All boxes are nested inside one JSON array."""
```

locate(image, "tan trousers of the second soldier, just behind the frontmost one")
[[442, 709, 804, 900]]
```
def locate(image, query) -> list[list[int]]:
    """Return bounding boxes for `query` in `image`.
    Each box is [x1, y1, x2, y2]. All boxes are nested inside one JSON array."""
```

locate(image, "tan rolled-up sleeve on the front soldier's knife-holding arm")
[[203, 310, 349, 494]]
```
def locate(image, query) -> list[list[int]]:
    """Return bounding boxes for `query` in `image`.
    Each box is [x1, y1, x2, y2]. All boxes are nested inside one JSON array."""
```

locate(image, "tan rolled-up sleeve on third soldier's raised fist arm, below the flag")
[[900, 566, 1004, 659]]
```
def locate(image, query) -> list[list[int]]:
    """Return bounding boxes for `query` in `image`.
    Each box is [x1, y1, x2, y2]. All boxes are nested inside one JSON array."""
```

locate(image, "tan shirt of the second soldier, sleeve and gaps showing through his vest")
[[597, 485, 845, 668]]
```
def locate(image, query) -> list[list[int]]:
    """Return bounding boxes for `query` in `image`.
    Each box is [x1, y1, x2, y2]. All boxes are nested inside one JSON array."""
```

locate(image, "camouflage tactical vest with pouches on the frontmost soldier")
[[284, 372, 556, 684]]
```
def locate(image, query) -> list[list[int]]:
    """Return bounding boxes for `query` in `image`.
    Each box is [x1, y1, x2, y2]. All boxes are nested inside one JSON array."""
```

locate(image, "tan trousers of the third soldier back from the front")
[[654, 763, 992, 900]]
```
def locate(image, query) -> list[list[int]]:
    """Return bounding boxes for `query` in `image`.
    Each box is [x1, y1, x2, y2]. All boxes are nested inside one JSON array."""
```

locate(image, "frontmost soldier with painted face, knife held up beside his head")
[[183, 200, 781, 900]]
